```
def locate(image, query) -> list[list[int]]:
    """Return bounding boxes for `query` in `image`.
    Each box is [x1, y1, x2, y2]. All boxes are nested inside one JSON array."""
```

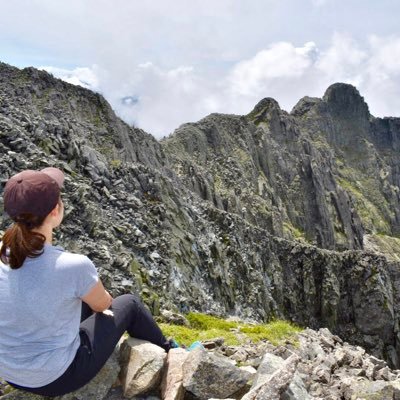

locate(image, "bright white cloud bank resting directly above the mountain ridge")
[[40, 33, 400, 137]]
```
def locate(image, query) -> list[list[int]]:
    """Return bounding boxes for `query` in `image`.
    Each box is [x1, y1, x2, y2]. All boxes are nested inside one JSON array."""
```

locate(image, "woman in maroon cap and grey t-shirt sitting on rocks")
[[0, 167, 171, 396]]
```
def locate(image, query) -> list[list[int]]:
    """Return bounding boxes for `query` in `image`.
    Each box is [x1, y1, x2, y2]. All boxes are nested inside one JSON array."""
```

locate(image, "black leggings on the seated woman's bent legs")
[[9, 294, 170, 396]]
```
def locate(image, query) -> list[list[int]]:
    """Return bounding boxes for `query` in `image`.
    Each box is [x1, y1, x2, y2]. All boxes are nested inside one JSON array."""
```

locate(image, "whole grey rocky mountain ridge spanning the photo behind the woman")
[[0, 63, 400, 366]]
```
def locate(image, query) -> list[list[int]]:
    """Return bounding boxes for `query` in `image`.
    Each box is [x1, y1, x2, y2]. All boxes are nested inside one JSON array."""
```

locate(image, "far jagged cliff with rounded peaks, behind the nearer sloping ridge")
[[161, 84, 400, 250]]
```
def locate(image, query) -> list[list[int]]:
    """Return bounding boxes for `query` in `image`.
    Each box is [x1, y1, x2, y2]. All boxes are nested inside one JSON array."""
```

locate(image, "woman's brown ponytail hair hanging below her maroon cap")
[[0, 214, 46, 269]]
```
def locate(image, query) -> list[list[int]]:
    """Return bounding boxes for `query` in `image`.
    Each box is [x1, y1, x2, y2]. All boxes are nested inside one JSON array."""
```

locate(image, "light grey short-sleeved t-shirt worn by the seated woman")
[[0, 242, 99, 387]]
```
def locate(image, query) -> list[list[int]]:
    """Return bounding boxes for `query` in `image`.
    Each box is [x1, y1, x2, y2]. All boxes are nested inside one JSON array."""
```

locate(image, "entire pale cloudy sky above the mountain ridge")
[[0, 0, 400, 137]]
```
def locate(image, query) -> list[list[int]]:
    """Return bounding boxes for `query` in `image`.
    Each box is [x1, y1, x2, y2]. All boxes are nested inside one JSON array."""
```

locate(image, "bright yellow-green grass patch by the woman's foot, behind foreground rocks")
[[159, 313, 302, 346]]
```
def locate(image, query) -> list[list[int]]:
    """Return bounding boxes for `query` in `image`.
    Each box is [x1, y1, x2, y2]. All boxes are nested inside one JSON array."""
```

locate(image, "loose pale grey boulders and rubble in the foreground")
[[0, 329, 400, 400]]
